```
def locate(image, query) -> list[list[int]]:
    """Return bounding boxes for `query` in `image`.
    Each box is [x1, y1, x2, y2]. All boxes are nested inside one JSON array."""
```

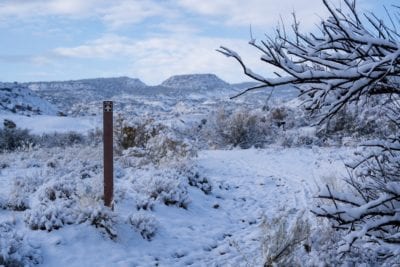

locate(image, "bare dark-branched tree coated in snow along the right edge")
[[218, 0, 400, 262]]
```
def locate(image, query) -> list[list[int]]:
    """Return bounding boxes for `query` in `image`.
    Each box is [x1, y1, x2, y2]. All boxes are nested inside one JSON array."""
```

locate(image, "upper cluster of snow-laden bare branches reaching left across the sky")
[[217, 0, 400, 119]]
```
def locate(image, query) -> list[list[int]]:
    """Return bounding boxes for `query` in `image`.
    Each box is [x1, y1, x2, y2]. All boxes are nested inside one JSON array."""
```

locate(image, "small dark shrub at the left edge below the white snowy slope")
[[0, 128, 37, 152]]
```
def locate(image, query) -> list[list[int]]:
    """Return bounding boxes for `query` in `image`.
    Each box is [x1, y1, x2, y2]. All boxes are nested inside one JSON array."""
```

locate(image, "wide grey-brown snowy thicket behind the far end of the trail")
[[202, 104, 310, 148]]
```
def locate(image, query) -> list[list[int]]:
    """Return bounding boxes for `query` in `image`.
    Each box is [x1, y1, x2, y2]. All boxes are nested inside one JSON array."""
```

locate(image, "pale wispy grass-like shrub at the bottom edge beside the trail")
[[261, 211, 311, 266]]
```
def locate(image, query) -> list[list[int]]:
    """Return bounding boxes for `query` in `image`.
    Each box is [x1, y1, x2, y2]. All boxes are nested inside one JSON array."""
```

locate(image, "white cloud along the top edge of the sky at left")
[[0, 0, 175, 29]]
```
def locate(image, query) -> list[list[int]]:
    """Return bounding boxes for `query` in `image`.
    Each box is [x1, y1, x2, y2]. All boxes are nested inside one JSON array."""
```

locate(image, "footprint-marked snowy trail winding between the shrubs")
[[177, 148, 348, 266]]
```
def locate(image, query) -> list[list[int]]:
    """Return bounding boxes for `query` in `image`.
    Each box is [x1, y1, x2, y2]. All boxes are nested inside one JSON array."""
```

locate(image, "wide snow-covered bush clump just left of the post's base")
[[24, 174, 117, 239]]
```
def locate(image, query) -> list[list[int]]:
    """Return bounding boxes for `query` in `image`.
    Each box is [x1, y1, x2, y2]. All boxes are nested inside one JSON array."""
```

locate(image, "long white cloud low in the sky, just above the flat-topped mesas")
[[54, 35, 276, 84]]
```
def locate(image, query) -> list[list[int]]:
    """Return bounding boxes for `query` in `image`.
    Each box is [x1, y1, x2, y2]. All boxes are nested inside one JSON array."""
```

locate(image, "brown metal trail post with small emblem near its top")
[[103, 101, 114, 207]]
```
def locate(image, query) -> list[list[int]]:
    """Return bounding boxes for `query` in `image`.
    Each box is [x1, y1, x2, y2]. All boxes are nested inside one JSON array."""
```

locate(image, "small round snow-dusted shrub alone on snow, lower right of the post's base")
[[128, 212, 158, 240]]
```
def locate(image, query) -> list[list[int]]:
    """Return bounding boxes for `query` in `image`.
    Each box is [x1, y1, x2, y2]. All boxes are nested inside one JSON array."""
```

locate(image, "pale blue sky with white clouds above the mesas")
[[0, 0, 397, 85]]
